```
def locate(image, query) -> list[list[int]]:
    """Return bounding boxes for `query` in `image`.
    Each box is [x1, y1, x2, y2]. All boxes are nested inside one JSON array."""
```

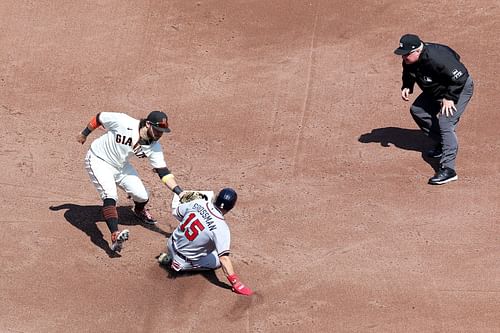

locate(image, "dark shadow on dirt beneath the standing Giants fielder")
[[49, 203, 170, 258]]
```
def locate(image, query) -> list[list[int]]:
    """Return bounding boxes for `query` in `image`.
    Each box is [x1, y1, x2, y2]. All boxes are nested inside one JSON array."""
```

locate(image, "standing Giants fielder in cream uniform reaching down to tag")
[[77, 111, 187, 252]]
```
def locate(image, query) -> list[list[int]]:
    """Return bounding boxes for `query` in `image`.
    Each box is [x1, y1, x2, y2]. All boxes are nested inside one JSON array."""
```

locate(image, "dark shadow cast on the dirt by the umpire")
[[358, 127, 439, 171]]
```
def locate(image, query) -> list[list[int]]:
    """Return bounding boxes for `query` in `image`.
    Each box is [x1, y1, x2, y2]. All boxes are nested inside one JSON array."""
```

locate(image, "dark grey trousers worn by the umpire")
[[410, 76, 474, 170]]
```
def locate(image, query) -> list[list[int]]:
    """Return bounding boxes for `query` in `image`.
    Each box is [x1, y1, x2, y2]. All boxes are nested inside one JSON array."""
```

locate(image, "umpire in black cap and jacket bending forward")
[[394, 34, 474, 185]]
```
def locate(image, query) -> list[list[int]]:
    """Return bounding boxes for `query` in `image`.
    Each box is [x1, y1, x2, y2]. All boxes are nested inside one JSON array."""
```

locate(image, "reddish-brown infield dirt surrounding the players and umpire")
[[0, 0, 500, 332]]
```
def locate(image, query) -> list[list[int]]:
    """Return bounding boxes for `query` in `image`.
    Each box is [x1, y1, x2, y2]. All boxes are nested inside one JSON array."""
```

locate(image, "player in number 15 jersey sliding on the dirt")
[[158, 188, 253, 296]]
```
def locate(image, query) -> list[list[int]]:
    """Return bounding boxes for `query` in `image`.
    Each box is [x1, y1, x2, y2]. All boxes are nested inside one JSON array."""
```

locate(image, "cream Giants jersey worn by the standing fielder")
[[90, 112, 167, 170]]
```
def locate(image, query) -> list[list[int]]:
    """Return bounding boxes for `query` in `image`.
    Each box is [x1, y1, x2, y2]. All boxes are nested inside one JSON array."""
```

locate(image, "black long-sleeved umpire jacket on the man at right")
[[402, 43, 469, 103]]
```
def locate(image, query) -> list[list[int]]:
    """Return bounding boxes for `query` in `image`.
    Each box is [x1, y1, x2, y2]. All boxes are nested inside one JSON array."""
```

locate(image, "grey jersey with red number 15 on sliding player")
[[171, 199, 231, 261]]
